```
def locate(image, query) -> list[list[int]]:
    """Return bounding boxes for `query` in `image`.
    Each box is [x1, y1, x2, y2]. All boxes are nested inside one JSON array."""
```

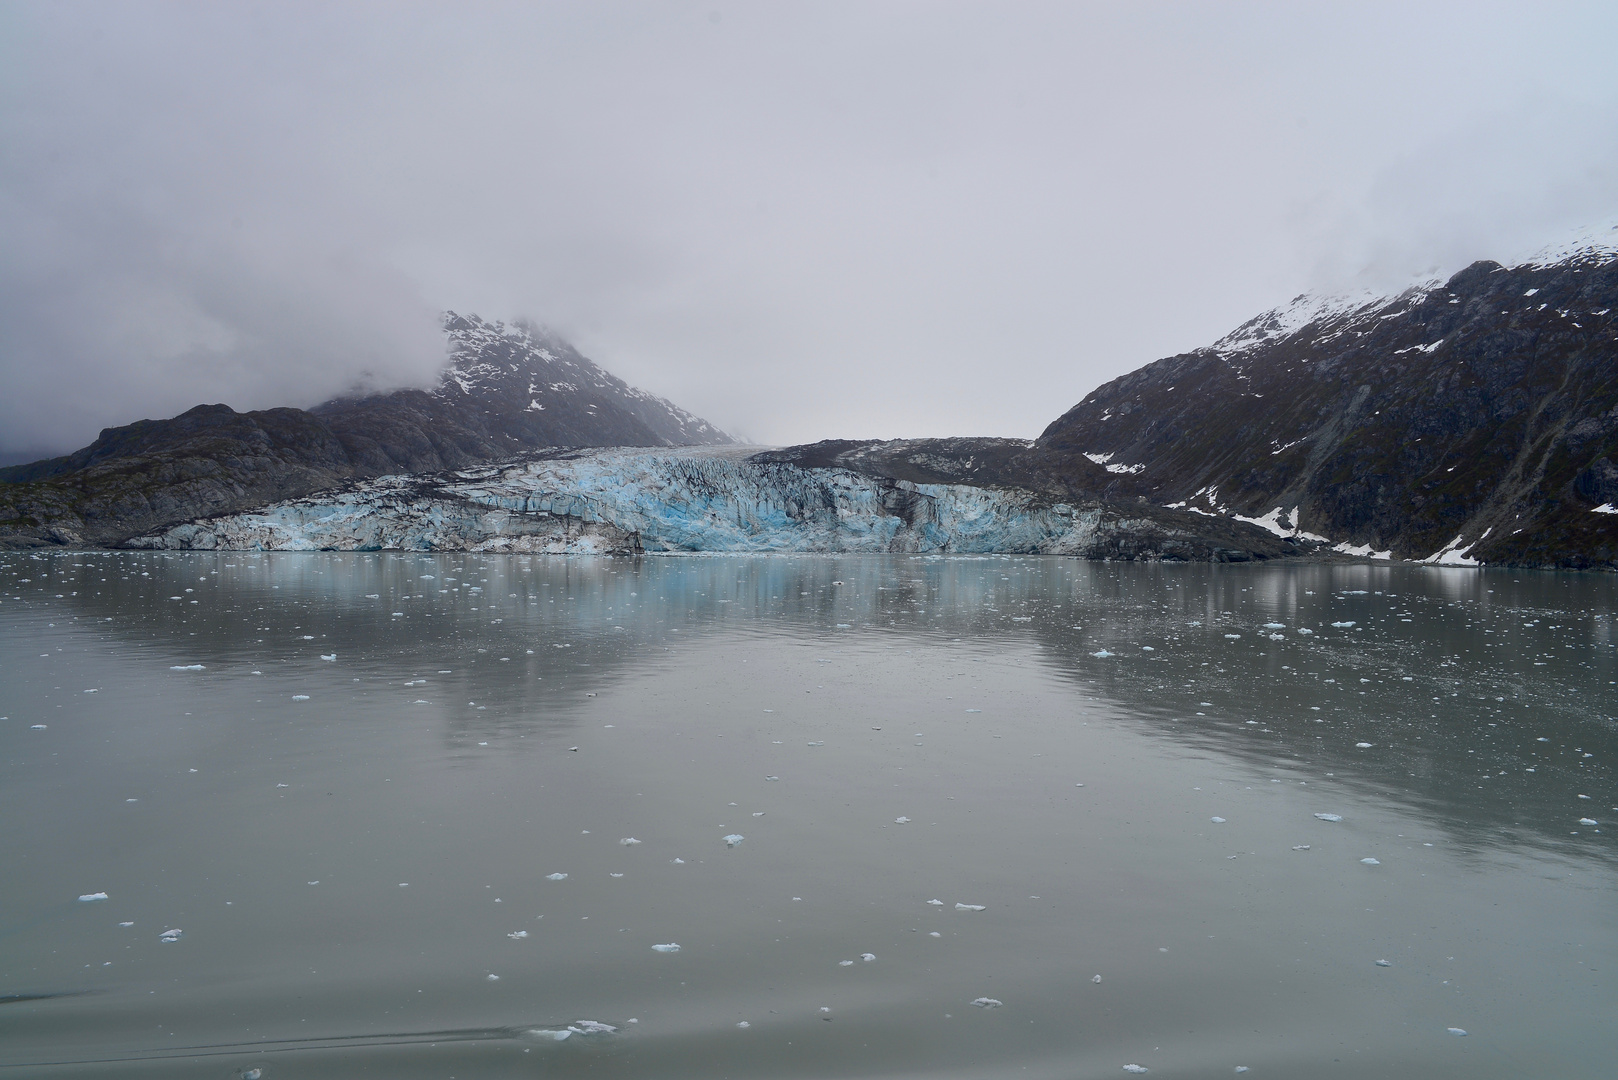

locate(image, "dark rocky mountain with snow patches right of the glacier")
[[1032, 230, 1618, 568]]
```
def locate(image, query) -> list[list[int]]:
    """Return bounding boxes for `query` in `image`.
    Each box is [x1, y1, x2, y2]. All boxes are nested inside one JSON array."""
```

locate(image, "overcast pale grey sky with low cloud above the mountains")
[[0, 0, 1618, 452]]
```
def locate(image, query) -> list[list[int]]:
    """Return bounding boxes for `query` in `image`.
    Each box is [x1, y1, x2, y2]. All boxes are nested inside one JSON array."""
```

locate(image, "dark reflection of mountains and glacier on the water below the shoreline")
[[19, 552, 1618, 844]]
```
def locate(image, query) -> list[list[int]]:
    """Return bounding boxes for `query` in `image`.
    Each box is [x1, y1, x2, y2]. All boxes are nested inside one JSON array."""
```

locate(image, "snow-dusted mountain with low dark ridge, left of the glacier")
[[0, 313, 730, 546]]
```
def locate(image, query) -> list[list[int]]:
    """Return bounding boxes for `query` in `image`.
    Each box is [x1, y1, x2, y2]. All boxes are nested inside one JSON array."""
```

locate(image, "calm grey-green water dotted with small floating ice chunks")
[[0, 554, 1618, 1080]]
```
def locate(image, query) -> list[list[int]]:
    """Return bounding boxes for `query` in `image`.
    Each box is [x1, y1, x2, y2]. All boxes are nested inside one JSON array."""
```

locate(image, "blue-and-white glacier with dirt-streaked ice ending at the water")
[[129, 450, 1293, 562]]
